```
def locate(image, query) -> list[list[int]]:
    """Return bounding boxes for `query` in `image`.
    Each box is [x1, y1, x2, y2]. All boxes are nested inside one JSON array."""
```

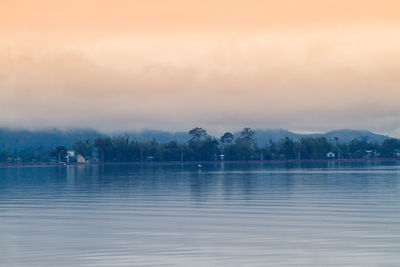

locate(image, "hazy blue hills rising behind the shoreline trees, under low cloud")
[[0, 128, 389, 151]]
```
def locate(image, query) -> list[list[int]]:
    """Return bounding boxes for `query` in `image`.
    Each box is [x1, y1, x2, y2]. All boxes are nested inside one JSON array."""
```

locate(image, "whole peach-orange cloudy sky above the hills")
[[0, 0, 400, 137]]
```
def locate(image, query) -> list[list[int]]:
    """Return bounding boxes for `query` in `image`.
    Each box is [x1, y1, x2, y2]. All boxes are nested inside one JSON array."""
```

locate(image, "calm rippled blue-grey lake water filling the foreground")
[[0, 162, 400, 266]]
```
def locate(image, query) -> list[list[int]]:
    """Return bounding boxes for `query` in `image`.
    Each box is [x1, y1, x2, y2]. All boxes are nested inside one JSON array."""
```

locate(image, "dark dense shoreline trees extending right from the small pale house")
[[75, 131, 400, 162]]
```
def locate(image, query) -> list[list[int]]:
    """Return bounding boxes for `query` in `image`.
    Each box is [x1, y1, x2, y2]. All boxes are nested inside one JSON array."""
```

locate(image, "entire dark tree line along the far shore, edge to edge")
[[0, 127, 400, 163]]
